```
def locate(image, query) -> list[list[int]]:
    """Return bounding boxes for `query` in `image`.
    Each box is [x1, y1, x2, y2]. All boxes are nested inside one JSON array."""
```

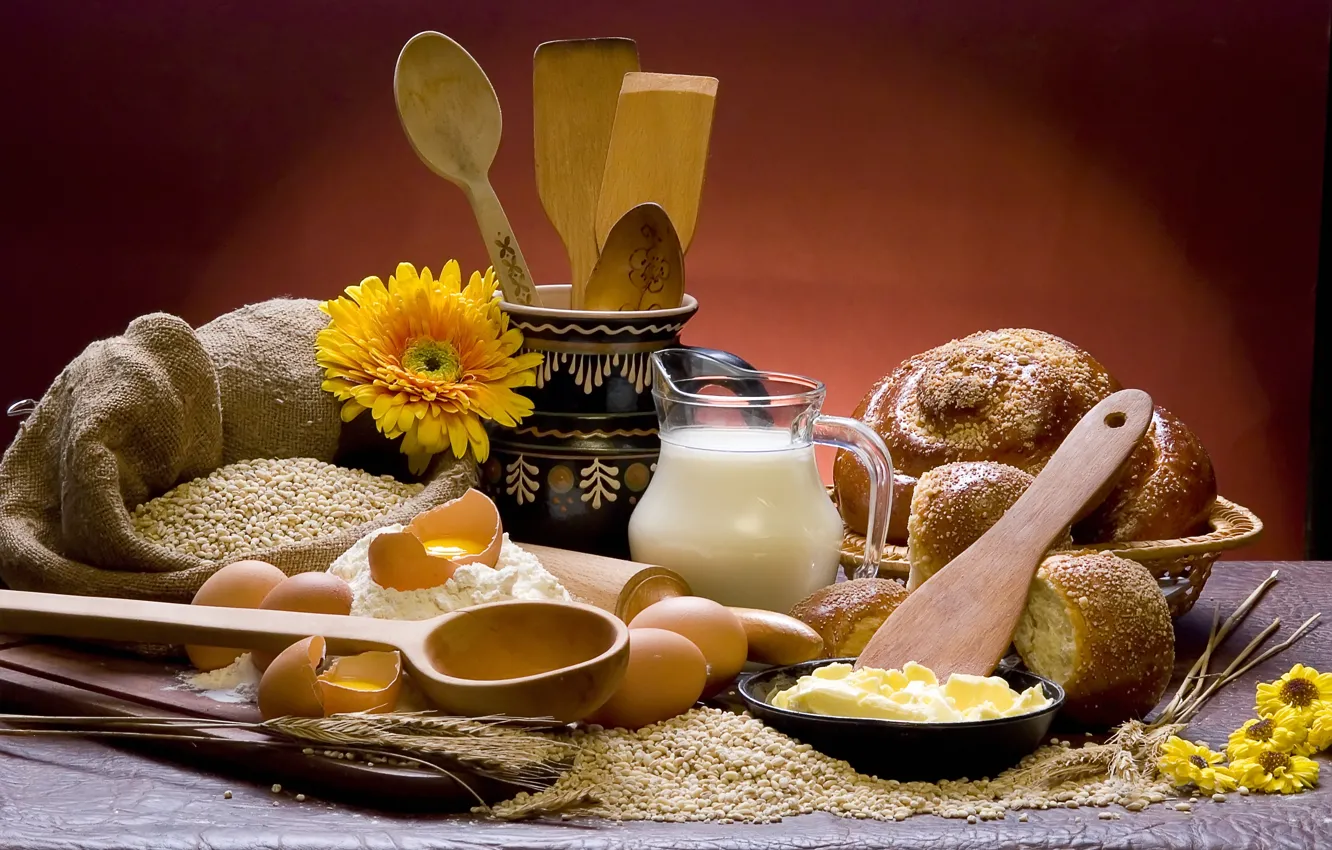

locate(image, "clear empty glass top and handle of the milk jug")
[[651, 348, 892, 578]]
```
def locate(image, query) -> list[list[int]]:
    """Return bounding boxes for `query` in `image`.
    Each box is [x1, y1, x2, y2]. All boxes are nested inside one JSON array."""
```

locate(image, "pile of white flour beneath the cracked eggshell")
[[328, 525, 573, 620]]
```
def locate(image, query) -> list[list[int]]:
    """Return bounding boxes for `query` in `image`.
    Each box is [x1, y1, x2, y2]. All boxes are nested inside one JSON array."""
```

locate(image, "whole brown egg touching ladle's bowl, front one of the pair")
[[587, 629, 707, 729]]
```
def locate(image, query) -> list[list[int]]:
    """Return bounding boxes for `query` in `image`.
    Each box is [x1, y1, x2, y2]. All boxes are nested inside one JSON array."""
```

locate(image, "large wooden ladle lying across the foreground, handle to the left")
[[0, 590, 629, 722]]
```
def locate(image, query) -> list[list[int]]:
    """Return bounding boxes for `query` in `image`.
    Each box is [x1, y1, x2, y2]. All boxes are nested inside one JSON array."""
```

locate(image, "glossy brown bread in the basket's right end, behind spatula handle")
[[1074, 406, 1216, 544]]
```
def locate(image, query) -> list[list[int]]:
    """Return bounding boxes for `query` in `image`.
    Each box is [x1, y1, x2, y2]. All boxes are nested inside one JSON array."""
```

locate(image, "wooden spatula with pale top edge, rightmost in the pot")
[[597, 72, 717, 258]]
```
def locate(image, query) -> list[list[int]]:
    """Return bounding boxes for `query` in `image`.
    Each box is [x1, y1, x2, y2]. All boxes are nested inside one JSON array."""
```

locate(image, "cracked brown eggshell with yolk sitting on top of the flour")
[[369, 489, 503, 590]]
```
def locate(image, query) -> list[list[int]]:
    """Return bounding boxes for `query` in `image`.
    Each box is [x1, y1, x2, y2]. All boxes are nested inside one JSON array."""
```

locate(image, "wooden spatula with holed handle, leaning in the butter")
[[855, 389, 1152, 681]]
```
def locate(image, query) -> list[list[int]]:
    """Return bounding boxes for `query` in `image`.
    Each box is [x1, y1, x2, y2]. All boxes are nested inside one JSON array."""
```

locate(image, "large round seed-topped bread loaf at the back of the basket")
[[834, 329, 1119, 542]]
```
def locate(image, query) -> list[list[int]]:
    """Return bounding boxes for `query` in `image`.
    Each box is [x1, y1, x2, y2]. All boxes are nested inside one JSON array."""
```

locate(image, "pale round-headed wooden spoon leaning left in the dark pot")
[[393, 32, 541, 304]]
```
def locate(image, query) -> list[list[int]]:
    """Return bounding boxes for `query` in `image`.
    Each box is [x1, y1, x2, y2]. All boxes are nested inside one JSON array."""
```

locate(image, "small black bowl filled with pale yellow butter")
[[739, 658, 1064, 781]]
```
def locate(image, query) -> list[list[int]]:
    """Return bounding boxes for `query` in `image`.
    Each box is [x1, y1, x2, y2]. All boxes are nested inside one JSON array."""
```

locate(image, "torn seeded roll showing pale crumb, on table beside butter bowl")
[[1014, 553, 1175, 726]]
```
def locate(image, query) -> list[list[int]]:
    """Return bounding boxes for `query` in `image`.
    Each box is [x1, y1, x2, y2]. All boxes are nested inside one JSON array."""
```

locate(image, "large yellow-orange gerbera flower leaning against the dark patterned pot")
[[316, 260, 541, 473]]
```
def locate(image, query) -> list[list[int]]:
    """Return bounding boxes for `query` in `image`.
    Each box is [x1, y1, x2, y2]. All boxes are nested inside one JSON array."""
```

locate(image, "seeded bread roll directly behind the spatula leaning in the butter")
[[907, 461, 1072, 590]]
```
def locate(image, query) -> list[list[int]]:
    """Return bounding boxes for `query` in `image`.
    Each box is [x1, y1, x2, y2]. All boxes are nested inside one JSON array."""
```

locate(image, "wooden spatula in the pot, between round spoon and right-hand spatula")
[[531, 39, 638, 310]]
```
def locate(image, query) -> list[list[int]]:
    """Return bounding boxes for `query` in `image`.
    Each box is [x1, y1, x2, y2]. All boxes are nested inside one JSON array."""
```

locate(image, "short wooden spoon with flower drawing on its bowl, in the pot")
[[583, 204, 685, 310]]
